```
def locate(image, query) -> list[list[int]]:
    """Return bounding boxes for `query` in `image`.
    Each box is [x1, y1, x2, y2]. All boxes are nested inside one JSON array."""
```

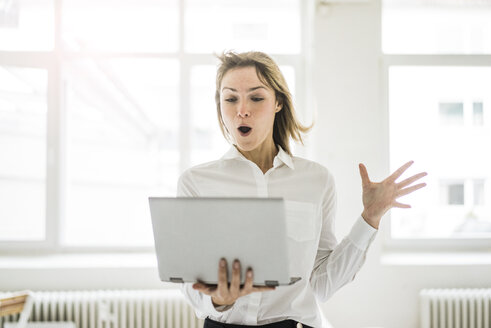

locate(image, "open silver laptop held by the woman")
[[149, 197, 300, 286]]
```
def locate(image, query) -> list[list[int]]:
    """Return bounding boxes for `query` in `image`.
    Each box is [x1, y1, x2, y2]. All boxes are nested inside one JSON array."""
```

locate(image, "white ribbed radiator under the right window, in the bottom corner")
[[419, 289, 491, 328]]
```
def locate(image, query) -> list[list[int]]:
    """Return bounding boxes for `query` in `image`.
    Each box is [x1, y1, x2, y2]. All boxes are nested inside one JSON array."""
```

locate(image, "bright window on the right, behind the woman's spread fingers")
[[382, 0, 491, 247]]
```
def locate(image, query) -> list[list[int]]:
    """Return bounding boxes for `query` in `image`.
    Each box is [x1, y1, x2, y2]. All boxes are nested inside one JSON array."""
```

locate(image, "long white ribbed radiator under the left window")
[[0, 289, 203, 328]]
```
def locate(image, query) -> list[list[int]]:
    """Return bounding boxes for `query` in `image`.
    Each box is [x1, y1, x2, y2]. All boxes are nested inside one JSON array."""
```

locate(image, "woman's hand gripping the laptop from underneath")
[[193, 259, 275, 306]]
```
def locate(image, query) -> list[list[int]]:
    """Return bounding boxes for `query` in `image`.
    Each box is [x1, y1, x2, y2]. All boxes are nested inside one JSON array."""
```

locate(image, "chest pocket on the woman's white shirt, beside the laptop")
[[285, 201, 315, 241]]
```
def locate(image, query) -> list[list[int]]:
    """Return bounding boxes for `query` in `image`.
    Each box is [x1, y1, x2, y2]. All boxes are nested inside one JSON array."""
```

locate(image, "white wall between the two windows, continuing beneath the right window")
[[313, 1, 491, 328]]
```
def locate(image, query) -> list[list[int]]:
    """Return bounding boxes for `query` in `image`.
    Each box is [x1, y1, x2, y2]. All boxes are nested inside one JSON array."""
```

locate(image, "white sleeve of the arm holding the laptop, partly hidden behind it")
[[177, 171, 232, 319]]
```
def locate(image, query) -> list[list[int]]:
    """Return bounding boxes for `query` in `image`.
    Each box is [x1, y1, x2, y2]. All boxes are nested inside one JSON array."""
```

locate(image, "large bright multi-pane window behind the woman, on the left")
[[0, 0, 307, 252]]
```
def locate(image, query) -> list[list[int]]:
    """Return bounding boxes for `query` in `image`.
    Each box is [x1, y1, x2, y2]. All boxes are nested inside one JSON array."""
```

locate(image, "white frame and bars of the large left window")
[[0, 0, 315, 255]]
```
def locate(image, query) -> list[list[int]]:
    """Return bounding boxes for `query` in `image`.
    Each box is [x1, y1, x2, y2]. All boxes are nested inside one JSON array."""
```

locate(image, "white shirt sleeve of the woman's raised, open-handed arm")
[[310, 172, 377, 302]]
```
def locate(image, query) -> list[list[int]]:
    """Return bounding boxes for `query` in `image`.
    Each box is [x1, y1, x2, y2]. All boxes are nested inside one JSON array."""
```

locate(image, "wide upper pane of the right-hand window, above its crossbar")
[[382, 0, 491, 54]]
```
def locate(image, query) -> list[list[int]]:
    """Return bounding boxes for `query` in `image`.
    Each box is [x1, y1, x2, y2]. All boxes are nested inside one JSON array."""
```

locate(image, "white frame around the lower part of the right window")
[[381, 53, 491, 252]]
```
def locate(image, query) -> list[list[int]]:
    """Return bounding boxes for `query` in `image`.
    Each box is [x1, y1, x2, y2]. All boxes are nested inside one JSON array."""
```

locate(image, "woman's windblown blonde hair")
[[215, 51, 313, 155]]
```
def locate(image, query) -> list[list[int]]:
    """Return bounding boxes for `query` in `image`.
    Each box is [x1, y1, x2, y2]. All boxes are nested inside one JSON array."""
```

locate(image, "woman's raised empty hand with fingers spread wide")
[[359, 161, 427, 229]]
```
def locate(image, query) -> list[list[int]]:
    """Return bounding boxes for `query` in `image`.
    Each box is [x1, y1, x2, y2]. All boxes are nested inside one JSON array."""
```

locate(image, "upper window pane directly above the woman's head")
[[185, 0, 301, 54]]
